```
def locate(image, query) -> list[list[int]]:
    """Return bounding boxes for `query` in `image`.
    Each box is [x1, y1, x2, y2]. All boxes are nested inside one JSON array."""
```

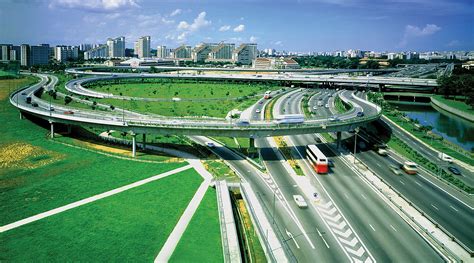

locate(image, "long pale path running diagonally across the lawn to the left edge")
[[0, 165, 192, 233]]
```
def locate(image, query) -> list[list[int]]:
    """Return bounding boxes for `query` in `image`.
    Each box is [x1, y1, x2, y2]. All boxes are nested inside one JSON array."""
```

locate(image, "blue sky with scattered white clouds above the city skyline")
[[0, 0, 474, 52]]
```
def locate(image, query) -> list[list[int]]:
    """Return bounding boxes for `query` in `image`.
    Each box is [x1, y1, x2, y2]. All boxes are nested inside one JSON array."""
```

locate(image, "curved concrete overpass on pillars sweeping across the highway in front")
[[10, 74, 381, 157]]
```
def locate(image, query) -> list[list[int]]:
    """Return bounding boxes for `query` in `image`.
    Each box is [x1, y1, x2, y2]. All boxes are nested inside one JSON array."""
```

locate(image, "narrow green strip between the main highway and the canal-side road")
[[388, 137, 474, 194]]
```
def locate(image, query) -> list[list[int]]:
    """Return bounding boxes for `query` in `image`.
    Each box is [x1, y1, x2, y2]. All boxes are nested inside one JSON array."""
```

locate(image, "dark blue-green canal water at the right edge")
[[396, 104, 474, 151]]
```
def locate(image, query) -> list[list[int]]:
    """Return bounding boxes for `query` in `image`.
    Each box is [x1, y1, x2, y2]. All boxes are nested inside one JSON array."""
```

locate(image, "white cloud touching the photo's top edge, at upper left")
[[49, 0, 138, 12]]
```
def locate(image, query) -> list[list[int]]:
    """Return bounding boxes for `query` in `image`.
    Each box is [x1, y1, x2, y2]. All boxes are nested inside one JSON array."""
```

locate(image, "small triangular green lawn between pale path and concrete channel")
[[170, 188, 224, 262]]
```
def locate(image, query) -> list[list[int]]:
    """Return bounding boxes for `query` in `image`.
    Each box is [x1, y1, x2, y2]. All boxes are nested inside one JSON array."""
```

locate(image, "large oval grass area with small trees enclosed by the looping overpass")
[[84, 80, 279, 117]]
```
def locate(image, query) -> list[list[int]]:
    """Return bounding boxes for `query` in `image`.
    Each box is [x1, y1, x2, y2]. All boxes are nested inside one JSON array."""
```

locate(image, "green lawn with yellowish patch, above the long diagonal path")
[[0, 78, 185, 225]]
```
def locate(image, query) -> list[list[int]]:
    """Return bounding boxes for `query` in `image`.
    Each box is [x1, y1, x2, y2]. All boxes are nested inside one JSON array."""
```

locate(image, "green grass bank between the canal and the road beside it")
[[369, 93, 474, 165]]
